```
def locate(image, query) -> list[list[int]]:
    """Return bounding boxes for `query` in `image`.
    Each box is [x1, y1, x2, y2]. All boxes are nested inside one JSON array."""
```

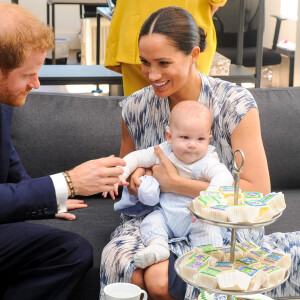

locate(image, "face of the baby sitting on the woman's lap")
[[167, 118, 211, 164]]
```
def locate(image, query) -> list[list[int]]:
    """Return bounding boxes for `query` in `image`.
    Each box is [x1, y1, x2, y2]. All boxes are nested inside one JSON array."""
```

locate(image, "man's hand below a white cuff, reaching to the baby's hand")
[[69, 155, 126, 196]]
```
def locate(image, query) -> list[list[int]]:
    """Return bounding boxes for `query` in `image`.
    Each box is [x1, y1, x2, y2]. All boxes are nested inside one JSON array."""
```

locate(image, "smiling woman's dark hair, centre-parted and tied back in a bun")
[[139, 6, 206, 55]]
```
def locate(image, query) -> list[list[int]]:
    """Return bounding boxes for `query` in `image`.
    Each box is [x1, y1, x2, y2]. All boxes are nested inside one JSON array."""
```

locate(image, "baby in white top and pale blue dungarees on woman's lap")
[[105, 101, 233, 268]]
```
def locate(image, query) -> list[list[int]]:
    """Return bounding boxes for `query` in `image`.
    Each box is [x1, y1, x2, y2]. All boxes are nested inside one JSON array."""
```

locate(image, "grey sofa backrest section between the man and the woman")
[[12, 93, 123, 177]]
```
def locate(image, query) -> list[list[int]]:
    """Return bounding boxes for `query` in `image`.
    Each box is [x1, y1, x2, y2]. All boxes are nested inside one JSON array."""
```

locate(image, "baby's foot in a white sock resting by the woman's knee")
[[134, 239, 170, 269]]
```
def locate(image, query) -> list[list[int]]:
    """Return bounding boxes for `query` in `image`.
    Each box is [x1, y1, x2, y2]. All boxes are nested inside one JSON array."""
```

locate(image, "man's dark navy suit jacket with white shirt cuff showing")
[[0, 104, 57, 224]]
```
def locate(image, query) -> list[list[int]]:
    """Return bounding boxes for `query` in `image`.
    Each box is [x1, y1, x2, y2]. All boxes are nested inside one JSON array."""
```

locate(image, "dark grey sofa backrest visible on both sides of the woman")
[[12, 87, 300, 190]]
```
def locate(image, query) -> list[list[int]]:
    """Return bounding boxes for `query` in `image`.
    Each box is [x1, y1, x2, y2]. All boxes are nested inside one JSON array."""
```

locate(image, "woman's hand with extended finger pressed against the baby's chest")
[[152, 145, 179, 192]]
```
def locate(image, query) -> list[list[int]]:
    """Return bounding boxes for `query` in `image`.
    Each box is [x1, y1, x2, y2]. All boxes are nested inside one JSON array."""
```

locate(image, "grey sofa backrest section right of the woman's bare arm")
[[251, 87, 300, 190]]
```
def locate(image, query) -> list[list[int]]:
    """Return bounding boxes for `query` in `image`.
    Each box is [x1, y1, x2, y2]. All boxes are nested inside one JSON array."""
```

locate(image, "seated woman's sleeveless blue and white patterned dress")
[[100, 74, 300, 299]]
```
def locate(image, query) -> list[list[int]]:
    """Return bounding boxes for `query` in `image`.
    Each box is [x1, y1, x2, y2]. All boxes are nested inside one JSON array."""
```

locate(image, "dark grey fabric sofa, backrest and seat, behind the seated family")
[[12, 88, 300, 300]]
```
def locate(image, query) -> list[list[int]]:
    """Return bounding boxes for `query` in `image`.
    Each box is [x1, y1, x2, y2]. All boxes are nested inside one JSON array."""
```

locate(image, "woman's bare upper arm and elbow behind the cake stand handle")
[[231, 108, 271, 194]]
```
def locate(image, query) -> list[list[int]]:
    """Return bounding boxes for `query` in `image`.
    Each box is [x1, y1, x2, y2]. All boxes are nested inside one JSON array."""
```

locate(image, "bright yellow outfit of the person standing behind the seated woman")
[[104, 0, 227, 96]]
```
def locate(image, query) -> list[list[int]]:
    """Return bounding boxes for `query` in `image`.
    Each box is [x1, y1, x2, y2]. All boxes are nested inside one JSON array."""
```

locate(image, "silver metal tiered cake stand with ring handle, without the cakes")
[[175, 150, 290, 300]]
